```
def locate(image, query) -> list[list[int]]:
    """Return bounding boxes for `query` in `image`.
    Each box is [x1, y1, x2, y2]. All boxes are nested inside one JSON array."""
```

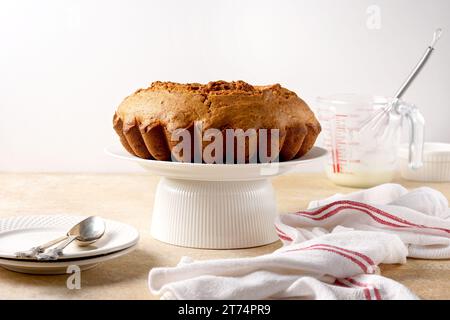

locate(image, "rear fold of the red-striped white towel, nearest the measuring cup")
[[284, 184, 450, 259]]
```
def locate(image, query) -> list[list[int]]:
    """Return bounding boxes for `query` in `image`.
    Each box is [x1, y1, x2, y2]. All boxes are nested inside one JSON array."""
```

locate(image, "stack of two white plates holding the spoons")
[[0, 215, 139, 274]]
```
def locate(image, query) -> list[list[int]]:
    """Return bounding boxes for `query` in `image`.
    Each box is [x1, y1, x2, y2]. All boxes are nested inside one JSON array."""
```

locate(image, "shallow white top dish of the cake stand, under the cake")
[[105, 145, 327, 181]]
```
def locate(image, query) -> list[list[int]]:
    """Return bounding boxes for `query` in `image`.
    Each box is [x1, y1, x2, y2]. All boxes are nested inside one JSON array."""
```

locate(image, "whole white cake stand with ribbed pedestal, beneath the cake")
[[105, 146, 326, 249]]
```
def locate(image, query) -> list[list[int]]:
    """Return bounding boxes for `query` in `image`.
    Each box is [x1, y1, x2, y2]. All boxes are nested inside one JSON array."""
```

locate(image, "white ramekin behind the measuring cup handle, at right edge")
[[399, 142, 450, 182]]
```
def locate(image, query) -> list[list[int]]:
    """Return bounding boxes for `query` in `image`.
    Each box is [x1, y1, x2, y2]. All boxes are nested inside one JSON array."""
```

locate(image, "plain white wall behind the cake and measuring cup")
[[0, 0, 450, 172]]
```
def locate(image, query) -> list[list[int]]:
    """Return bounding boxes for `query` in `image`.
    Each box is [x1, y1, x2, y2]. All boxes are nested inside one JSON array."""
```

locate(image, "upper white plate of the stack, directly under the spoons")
[[0, 215, 139, 263]]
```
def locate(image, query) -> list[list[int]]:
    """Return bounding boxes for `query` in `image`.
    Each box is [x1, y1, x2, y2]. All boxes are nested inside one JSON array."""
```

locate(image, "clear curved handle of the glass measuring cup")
[[395, 100, 425, 169]]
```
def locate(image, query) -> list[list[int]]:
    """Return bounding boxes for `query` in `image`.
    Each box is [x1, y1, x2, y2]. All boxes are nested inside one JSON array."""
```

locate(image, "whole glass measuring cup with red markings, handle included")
[[317, 94, 424, 188]]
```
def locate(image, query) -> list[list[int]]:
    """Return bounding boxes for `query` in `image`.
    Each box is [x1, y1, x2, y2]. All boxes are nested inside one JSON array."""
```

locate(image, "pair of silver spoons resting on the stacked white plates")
[[15, 216, 105, 260]]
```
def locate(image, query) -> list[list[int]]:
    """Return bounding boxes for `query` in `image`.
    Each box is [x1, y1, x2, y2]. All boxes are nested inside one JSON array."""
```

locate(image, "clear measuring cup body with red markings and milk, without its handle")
[[318, 95, 400, 187]]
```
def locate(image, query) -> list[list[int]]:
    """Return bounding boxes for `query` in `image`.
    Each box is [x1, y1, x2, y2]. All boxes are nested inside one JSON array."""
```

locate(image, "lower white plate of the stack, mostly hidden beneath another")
[[0, 245, 137, 275]]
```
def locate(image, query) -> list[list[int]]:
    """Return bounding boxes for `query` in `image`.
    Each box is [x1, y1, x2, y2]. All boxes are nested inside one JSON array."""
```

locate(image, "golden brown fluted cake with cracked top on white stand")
[[114, 81, 321, 160]]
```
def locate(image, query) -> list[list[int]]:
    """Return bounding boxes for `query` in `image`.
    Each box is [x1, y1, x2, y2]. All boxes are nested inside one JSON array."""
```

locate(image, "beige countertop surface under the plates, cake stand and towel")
[[0, 173, 450, 299]]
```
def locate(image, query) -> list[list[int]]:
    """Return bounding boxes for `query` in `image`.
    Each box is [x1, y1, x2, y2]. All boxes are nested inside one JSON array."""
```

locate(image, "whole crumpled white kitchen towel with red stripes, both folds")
[[149, 184, 450, 300]]
